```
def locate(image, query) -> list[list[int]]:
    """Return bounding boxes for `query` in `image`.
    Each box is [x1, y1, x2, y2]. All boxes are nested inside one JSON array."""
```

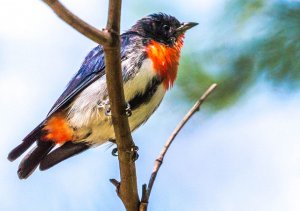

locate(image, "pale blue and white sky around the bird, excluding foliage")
[[0, 0, 300, 211]]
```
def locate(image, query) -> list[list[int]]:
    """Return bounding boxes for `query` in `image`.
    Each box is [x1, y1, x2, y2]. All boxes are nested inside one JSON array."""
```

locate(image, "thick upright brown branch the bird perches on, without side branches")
[[104, 0, 140, 211]]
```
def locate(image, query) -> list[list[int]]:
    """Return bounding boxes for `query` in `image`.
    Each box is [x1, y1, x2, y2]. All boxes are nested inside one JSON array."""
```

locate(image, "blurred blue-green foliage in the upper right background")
[[178, 0, 300, 109]]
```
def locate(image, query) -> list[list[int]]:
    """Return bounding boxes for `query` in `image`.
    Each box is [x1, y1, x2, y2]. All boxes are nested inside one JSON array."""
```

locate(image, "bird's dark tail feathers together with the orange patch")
[[8, 117, 90, 179]]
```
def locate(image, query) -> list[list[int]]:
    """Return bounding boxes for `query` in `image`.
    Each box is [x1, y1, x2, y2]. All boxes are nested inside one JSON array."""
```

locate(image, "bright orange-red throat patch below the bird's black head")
[[146, 35, 184, 89]]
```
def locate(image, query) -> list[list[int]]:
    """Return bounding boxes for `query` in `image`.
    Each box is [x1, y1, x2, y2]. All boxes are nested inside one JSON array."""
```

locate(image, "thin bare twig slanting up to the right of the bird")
[[140, 84, 217, 211]]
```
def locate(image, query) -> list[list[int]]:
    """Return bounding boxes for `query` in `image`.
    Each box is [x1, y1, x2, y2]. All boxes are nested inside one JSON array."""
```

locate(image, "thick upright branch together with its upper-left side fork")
[[43, 0, 140, 211]]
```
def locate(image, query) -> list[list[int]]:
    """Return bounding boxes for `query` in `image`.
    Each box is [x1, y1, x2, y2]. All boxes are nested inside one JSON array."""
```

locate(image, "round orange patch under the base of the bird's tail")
[[43, 116, 73, 144]]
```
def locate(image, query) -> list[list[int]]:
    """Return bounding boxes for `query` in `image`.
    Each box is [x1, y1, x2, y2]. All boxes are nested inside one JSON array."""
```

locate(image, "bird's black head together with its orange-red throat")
[[128, 13, 198, 89]]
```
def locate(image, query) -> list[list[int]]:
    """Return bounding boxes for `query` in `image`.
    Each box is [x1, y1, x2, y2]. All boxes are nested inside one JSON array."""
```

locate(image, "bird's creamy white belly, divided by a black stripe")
[[68, 59, 165, 145]]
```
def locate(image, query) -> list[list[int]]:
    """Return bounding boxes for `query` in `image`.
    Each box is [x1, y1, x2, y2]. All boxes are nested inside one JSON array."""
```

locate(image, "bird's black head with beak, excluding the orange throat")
[[129, 13, 198, 47]]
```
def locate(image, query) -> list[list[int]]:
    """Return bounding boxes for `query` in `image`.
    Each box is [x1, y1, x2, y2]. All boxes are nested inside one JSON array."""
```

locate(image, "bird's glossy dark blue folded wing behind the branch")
[[48, 36, 129, 116]]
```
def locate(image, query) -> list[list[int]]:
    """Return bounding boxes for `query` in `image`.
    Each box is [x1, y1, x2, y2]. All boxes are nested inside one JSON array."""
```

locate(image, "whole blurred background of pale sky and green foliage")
[[0, 0, 300, 211]]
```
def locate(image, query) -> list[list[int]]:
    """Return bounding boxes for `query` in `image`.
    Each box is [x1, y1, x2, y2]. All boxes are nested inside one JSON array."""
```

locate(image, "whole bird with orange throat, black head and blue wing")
[[8, 13, 198, 179]]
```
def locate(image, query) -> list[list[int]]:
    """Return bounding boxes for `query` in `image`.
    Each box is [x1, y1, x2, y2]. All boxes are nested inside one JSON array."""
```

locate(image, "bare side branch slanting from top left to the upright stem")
[[43, 0, 111, 46]]
